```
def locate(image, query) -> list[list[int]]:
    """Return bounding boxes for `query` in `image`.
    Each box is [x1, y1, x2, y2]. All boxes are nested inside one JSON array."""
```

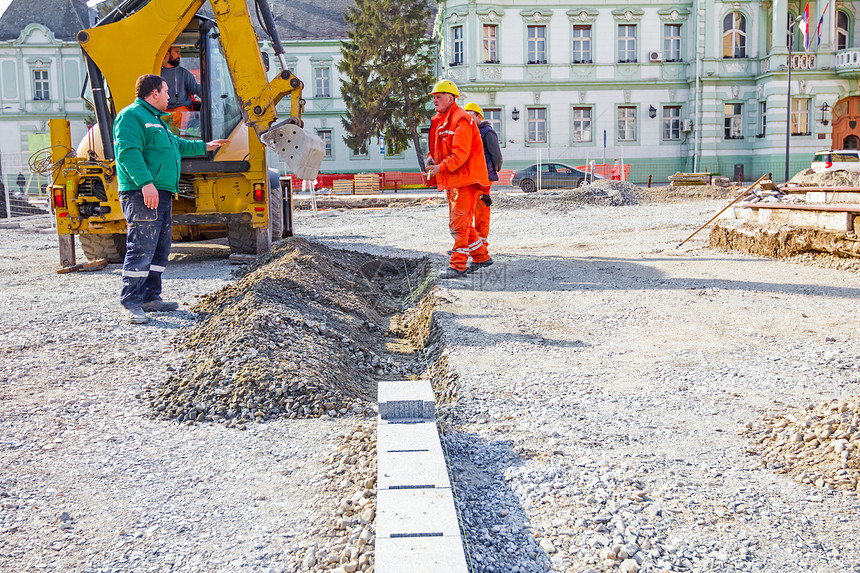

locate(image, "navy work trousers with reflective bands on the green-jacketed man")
[[119, 190, 173, 308]]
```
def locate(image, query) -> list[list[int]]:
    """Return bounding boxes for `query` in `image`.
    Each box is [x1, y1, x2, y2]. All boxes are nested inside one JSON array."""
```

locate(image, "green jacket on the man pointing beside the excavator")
[[113, 98, 206, 193]]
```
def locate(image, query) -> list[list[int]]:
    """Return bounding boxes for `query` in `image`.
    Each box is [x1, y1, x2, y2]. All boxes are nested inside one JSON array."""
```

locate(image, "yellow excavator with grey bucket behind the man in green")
[[49, 0, 325, 267]]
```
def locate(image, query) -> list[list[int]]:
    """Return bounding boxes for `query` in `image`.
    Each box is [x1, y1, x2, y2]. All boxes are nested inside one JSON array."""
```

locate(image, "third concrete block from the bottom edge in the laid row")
[[376, 445, 451, 490]]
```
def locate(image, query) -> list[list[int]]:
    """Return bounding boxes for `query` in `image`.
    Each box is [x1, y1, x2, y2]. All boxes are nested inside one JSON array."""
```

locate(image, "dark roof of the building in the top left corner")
[[0, 0, 89, 42]]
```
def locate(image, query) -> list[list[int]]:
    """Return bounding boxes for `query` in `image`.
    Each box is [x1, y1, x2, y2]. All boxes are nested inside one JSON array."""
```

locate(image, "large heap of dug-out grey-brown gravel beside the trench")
[[149, 238, 436, 427]]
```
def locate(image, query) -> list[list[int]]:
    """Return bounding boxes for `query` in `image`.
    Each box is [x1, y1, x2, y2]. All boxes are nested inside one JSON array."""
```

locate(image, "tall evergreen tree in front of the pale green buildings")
[[338, 0, 435, 171]]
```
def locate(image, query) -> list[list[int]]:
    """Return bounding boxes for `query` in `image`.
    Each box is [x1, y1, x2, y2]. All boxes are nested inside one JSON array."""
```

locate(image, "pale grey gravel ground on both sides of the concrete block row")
[[0, 189, 860, 573]]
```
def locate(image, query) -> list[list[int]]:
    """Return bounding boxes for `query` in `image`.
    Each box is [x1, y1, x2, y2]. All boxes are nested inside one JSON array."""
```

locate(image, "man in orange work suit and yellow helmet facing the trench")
[[427, 80, 491, 279]]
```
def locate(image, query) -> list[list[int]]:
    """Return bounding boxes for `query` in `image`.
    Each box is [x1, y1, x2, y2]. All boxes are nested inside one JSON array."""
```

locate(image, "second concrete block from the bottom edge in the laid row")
[[376, 488, 460, 540]]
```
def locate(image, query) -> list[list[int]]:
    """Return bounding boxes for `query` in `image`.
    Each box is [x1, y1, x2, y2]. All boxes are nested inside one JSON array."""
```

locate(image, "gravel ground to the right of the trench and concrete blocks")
[[298, 193, 860, 572]]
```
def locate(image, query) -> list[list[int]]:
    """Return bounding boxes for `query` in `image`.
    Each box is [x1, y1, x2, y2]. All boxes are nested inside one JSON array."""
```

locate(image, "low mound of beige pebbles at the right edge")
[[744, 397, 860, 491]]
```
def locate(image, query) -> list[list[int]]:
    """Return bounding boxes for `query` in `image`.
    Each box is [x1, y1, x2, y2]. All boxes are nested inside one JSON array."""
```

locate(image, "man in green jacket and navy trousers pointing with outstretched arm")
[[113, 74, 229, 324]]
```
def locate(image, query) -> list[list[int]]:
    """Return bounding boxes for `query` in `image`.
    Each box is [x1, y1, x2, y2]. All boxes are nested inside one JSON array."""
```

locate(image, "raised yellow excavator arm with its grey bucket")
[[78, 0, 325, 179]]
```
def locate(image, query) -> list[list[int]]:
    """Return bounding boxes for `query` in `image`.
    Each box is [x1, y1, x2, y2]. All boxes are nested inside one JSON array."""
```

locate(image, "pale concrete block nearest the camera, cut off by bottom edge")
[[374, 535, 468, 573]]
